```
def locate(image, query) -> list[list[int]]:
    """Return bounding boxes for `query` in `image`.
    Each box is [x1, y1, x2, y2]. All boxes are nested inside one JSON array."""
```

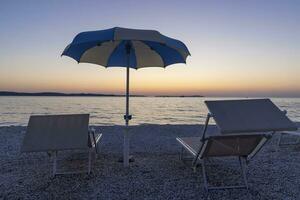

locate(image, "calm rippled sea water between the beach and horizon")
[[0, 97, 300, 126]]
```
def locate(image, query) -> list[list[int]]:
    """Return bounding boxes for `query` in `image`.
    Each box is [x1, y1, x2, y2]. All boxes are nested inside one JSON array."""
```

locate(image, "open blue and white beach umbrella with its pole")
[[62, 27, 190, 166]]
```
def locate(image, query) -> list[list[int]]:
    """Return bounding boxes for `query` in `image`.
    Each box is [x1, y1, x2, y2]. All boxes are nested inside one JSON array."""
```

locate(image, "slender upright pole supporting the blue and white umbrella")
[[123, 44, 131, 167]]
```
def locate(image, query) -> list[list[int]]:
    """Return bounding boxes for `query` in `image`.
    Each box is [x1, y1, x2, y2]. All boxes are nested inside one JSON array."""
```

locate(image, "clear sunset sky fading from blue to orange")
[[0, 0, 300, 97]]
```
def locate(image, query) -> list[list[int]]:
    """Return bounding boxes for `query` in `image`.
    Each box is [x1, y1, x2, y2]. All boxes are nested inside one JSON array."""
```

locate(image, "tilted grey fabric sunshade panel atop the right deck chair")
[[205, 99, 297, 133]]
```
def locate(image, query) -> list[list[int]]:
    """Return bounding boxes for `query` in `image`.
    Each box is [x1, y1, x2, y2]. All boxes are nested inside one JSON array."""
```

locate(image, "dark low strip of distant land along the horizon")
[[0, 91, 204, 97]]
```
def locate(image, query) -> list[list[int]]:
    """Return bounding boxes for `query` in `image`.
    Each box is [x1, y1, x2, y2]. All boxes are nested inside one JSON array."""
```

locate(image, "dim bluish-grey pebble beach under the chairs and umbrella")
[[0, 124, 300, 200]]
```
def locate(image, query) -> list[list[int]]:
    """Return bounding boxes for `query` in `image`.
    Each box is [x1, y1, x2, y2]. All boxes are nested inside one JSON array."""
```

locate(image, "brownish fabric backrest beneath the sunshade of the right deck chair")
[[200, 134, 270, 158]]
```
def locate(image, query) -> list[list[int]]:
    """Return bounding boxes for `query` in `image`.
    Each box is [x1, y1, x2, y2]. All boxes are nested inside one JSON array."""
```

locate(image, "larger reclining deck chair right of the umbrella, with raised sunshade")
[[176, 99, 296, 192]]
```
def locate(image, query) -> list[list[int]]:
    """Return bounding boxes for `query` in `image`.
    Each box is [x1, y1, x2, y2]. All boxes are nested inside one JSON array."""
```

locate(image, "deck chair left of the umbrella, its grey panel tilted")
[[21, 114, 102, 176]]
